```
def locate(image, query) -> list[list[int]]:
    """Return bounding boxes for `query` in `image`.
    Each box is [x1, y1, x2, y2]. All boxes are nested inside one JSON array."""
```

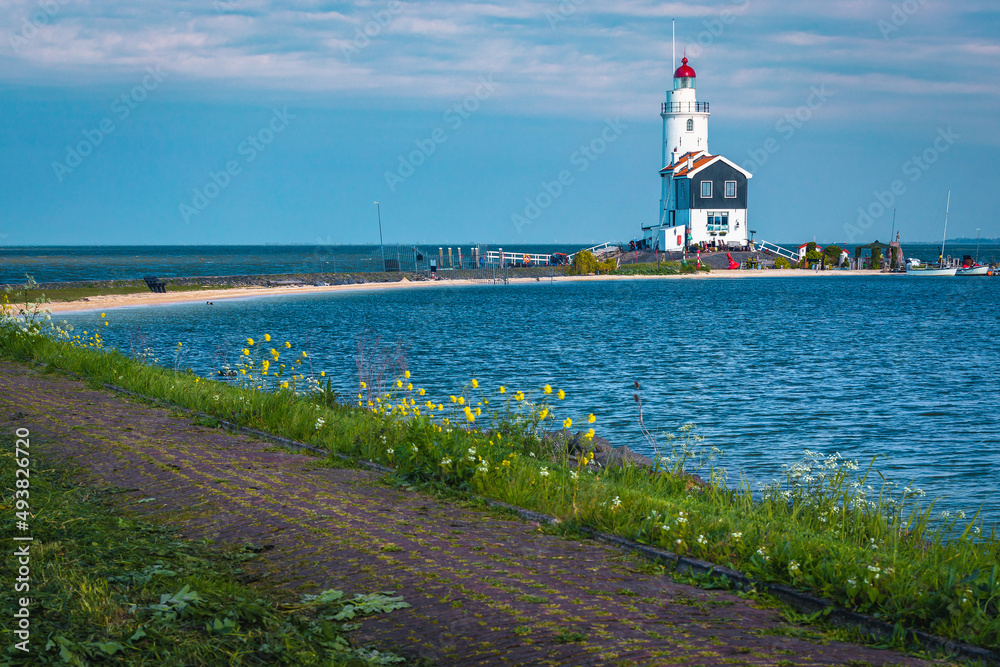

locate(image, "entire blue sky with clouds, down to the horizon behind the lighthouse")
[[0, 0, 1000, 245]]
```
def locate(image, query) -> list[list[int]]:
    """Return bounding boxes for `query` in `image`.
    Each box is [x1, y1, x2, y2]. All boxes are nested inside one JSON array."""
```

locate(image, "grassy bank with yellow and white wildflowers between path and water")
[[0, 310, 1000, 649]]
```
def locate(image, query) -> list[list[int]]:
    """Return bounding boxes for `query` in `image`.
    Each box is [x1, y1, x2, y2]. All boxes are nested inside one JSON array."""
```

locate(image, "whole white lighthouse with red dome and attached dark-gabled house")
[[642, 57, 752, 251]]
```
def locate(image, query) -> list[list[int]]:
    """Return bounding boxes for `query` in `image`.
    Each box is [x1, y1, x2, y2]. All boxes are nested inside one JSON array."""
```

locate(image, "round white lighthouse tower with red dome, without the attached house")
[[660, 57, 709, 224]]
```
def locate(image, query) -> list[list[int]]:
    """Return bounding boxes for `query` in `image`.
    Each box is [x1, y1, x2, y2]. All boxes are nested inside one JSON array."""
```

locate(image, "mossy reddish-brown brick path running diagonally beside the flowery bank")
[[0, 362, 944, 665]]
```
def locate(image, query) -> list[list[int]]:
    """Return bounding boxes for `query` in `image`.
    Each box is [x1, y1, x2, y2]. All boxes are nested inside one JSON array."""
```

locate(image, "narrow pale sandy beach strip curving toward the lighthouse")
[[46, 269, 905, 314]]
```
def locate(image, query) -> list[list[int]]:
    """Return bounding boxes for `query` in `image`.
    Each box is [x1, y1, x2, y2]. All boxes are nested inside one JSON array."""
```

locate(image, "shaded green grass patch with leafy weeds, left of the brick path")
[[0, 436, 407, 666]]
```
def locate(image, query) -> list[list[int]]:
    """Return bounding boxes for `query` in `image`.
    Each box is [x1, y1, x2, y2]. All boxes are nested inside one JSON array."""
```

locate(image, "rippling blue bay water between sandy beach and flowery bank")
[[58, 276, 1000, 522]]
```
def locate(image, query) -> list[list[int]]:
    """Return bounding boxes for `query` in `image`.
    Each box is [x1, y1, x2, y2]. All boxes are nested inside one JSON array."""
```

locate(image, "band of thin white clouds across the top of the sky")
[[0, 0, 1000, 141]]
